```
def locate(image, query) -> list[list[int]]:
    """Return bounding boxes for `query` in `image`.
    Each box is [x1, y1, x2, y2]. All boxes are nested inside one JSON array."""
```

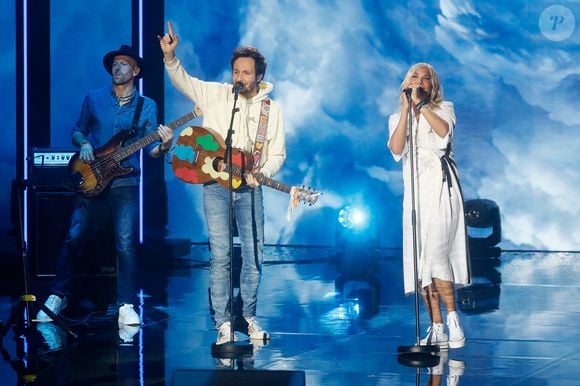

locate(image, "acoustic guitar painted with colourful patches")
[[171, 126, 321, 205]]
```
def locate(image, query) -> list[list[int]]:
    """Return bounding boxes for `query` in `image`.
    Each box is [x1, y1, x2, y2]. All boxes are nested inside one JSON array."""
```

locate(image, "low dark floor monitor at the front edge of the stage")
[[171, 369, 306, 386]]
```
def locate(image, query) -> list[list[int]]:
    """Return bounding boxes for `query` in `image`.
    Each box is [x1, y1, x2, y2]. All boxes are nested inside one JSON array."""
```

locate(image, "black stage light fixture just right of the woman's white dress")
[[464, 199, 501, 257]]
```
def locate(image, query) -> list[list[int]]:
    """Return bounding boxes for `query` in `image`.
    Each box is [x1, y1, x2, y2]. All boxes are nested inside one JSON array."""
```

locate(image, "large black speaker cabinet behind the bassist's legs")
[[28, 189, 117, 277]]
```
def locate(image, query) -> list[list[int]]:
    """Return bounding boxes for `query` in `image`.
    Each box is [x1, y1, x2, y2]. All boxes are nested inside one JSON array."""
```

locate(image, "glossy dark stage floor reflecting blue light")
[[0, 246, 580, 386]]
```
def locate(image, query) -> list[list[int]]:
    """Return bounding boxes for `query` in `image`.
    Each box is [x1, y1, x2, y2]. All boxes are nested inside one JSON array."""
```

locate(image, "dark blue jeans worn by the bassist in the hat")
[[52, 186, 139, 304]]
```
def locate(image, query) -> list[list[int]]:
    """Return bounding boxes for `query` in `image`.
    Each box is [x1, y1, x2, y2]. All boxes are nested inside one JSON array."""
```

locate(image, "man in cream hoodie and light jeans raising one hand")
[[158, 23, 286, 345]]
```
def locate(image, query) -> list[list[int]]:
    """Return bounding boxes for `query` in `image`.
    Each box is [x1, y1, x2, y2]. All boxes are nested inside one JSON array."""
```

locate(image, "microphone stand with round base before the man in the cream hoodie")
[[211, 84, 253, 358]]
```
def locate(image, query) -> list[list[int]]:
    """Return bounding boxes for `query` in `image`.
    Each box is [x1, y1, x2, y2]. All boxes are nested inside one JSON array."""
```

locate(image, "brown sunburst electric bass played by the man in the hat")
[[68, 110, 199, 197]]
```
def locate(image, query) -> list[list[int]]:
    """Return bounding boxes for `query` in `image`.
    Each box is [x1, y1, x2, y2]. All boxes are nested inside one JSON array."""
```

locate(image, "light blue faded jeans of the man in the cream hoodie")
[[203, 184, 264, 326]]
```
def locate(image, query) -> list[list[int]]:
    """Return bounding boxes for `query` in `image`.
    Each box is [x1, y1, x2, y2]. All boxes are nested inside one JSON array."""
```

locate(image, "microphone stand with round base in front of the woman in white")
[[397, 88, 439, 367]]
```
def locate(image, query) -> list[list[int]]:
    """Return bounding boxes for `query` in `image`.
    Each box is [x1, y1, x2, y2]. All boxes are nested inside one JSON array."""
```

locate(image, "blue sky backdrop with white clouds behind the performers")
[[0, 0, 580, 250]]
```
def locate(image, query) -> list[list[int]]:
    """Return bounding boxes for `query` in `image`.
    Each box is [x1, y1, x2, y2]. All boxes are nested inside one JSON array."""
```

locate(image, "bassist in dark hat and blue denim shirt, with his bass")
[[36, 45, 173, 341]]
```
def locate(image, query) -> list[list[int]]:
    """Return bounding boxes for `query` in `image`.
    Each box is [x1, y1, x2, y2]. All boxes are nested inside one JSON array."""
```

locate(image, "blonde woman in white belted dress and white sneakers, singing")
[[388, 63, 471, 349]]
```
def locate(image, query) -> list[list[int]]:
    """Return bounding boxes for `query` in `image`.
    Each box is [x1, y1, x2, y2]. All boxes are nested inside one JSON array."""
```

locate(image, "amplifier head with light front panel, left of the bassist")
[[28, 148, 77, 190]]
